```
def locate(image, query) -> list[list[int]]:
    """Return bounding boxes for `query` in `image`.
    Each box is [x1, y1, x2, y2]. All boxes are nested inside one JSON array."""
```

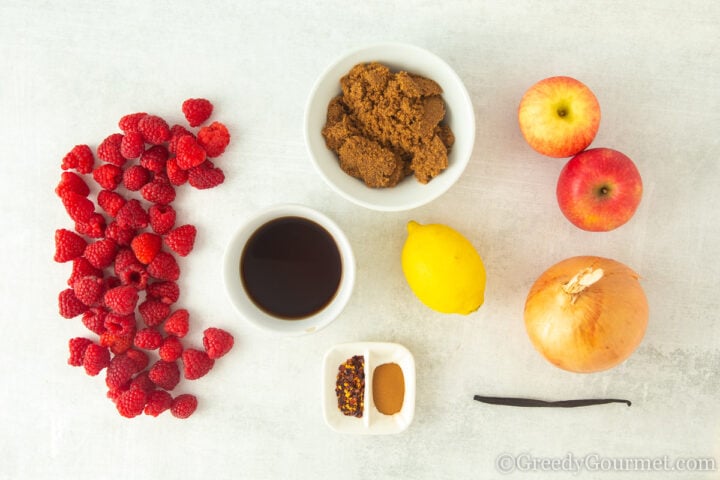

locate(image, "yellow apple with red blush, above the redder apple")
[[518, 76, 600, 158]]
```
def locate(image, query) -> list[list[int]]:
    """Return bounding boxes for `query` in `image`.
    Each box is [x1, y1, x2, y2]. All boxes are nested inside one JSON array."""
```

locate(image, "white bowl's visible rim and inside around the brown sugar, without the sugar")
[[304, 43, 475, 211]]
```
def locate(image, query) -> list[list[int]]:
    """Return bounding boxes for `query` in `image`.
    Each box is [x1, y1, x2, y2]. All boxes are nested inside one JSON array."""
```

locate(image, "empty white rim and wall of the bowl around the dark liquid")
[[223, 204, 356, 336]]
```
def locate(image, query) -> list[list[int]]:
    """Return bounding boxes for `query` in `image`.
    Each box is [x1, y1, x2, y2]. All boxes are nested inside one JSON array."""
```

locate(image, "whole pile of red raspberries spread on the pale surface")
[[54, 98, 234, 418]]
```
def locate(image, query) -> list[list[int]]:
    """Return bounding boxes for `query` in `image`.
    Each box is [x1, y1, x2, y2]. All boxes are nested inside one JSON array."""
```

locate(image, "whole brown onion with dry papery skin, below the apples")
[[525, 256, 648, 373]]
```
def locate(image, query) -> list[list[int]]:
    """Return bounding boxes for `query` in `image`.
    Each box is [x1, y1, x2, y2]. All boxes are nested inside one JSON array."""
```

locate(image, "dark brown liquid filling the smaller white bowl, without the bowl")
[[240, 217, 342, 320]]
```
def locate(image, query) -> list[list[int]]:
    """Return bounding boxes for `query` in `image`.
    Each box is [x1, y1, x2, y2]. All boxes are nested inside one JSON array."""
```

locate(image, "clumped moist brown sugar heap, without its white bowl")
[[322, 62, 455, 187]]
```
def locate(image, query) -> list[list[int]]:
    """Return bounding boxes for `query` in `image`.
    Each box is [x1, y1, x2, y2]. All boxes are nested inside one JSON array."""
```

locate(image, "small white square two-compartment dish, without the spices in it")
[[322, 342, 415, 435]]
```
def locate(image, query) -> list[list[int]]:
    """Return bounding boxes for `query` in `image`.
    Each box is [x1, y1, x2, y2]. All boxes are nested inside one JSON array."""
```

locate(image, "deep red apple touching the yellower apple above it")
[[556, 148, 643, 232]]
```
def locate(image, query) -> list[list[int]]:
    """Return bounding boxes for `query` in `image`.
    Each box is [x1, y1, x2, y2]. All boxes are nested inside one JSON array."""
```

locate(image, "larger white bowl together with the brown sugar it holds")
[[304, 43, 475, 211]]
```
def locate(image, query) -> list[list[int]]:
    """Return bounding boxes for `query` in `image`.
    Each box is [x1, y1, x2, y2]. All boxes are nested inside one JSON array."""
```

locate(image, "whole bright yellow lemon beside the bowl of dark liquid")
[[402, 220, 485, 315]]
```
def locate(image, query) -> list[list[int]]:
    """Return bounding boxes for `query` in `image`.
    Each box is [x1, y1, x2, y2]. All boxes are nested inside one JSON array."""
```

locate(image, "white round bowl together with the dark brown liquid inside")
[[223, 204, 355, 335]]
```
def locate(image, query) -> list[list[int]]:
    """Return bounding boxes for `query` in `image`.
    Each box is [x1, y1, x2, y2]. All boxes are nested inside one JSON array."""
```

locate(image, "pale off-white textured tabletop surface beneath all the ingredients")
[[0, 0, 720, 479]]
